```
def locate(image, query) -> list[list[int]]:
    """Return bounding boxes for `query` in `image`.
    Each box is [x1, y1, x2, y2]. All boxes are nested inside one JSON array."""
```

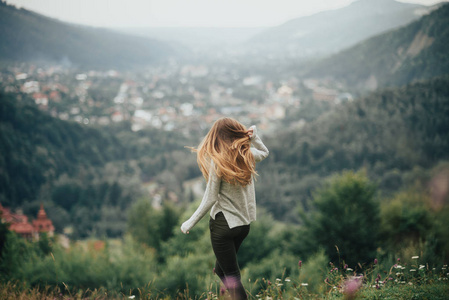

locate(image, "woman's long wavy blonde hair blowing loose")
[[192, 118, 257, 186]]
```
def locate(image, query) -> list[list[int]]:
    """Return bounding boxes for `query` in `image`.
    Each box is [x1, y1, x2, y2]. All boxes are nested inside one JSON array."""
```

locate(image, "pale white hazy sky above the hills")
[[6, 0, 449, 27]]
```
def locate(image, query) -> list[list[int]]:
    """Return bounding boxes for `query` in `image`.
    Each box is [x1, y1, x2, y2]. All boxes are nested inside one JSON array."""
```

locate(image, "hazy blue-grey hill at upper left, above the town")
[[0, 2, 176, 68]]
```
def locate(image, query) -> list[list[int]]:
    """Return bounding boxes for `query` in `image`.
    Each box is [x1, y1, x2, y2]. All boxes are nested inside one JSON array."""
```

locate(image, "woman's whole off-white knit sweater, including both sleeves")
[[181, 126, 269, 233]]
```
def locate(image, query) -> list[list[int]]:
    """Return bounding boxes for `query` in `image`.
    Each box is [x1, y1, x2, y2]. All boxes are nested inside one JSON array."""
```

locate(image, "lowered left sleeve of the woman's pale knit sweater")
[[181, 168, 221, 233]]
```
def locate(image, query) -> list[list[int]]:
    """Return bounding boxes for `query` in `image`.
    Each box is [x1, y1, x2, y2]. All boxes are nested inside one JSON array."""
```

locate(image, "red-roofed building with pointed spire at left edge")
[[0, 204, 55, 239]]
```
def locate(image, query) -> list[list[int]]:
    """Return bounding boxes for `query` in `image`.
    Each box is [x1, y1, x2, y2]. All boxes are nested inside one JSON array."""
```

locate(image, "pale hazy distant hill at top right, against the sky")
[[248, 0, 430, 56]]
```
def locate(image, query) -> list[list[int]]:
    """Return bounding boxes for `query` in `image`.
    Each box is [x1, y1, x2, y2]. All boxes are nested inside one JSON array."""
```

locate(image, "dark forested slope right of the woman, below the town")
[[256, 76, 449, 220]]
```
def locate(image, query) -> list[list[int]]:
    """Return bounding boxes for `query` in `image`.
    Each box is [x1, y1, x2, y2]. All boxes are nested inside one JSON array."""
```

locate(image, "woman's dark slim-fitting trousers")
[[209, 212, 250, 299]]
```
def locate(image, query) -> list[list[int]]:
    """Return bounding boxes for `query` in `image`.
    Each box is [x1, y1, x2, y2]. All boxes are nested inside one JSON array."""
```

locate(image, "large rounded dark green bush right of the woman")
[[303, 171, 379, 265]]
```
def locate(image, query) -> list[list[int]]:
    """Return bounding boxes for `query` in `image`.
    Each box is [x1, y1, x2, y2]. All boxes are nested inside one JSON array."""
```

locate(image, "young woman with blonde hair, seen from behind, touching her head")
[[181, 118, 268, 299]]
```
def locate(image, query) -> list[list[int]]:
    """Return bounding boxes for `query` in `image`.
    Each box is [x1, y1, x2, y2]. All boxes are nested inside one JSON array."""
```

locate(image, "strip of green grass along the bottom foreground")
[[0, 278, 449, 300]]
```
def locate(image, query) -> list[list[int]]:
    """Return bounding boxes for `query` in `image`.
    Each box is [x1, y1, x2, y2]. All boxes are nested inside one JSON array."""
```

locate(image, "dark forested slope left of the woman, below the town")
[[0, 93, 199, 237]]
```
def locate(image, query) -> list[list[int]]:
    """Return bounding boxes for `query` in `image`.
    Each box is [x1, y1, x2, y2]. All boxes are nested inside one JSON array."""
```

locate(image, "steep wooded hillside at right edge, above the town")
[[306, 4, 449, 89]]
